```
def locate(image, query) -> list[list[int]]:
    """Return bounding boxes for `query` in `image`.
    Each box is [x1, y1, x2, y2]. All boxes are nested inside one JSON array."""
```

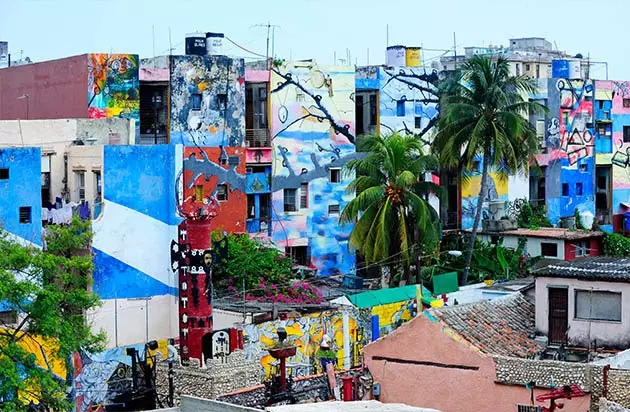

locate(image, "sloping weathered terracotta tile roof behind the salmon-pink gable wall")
[[428, 293, 541, 358]]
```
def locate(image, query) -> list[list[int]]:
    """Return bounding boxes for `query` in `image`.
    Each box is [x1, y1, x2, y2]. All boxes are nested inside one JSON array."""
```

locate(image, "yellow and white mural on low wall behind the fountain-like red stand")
[[243, 309, 370, 377]]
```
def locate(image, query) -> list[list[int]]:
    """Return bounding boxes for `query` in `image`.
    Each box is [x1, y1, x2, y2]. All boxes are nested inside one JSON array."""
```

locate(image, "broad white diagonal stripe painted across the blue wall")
[[92, 200, 177, 287]]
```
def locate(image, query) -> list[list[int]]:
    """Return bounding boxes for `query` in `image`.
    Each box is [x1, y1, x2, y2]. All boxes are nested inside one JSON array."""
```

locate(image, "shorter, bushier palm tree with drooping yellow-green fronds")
[[340, 134, 441, 282]]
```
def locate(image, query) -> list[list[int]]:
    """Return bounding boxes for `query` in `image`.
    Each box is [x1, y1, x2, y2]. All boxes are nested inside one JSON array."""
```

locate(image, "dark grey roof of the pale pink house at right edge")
[[534, 256, 630, 282]]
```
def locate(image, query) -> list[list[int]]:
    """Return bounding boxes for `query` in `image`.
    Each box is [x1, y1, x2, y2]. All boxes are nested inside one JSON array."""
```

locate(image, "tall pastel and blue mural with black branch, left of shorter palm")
[[271, 62, 359, 275]]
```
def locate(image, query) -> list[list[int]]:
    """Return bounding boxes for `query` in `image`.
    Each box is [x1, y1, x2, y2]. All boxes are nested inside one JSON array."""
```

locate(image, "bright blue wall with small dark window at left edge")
[[0, 147, 42, 246]]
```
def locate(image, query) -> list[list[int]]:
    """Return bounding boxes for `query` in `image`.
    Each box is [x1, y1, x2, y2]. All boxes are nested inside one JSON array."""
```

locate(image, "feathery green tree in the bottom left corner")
[[0, 218, 104, 411]]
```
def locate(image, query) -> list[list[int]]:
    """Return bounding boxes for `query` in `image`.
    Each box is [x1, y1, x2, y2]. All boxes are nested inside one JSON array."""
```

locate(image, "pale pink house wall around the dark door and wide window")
[[536, 277, 630, 348]]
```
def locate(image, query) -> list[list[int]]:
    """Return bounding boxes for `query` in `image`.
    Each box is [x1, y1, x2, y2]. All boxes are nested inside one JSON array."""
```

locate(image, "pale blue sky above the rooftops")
[[0, 0, 630, 80]]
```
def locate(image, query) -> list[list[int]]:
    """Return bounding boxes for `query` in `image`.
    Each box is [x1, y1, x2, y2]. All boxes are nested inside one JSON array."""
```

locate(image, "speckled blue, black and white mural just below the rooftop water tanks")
[[170, 56, 245, 147]]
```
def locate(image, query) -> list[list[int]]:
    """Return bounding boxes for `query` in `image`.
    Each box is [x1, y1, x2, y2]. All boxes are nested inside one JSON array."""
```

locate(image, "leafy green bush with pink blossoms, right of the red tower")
[[213, 232, 323, 304]]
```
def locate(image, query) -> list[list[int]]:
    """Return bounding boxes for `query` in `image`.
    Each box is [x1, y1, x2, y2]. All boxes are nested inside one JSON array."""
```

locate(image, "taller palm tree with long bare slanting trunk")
[[433, 56, 547, 284]]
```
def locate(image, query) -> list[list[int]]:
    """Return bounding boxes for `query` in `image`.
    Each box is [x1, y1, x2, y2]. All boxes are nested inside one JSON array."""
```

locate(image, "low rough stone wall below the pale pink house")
[[494, 356, 630, 410]]
